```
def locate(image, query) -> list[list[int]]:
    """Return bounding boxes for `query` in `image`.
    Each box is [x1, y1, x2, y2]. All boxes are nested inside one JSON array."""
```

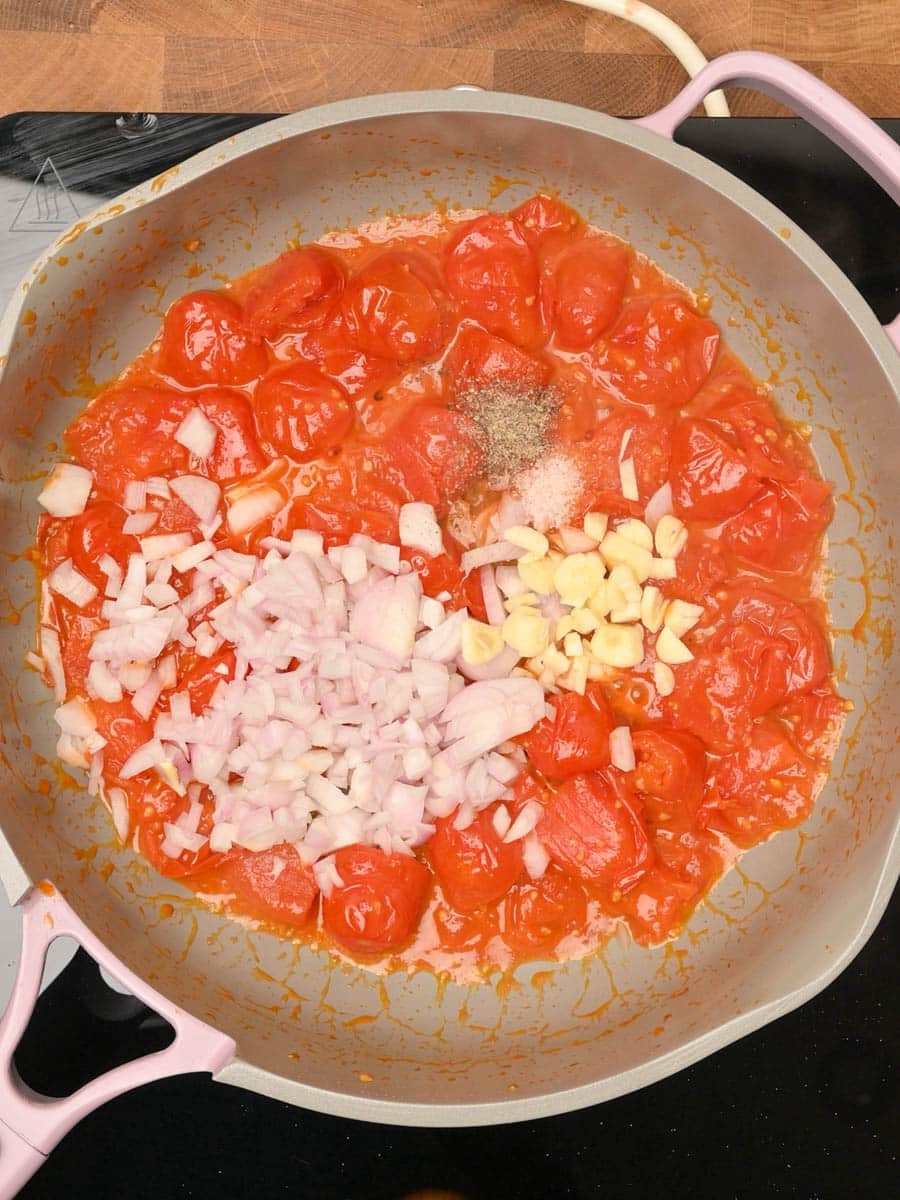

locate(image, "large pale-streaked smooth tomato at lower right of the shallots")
[[538, 767, 653, 894]]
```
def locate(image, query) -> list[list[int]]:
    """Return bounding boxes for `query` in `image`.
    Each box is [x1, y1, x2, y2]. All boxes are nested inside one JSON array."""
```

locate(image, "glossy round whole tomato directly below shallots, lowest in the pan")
[[322, 846, 431, 954]]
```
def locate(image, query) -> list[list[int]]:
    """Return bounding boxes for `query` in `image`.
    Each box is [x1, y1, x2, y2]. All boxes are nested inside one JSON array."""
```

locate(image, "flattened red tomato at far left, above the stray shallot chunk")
[[66, 385, 192, 498]]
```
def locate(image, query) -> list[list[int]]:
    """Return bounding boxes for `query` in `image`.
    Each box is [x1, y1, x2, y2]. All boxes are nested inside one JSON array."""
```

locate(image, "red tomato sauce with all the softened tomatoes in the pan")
[[38, 196, 844, 973]]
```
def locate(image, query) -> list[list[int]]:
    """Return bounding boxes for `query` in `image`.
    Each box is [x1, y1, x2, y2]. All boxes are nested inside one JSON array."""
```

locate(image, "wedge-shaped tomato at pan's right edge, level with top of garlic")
[[722, 479, 832, 574]]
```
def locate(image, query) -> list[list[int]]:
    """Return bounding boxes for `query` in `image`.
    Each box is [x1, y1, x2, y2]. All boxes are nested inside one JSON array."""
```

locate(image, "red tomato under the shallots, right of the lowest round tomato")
[[428, 804, 522, 913]]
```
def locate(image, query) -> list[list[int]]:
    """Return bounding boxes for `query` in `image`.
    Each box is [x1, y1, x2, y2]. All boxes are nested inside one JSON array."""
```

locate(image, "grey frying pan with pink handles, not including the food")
[[0, 54, 900, 1195]]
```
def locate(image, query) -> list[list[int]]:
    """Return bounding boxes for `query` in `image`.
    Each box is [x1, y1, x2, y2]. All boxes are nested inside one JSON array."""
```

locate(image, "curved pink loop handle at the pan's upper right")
[[635, 50, 900, 350]]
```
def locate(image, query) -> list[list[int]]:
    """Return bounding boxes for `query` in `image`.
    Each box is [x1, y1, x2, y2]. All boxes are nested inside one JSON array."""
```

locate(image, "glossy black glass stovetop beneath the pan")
[[0, 114, 900, 1200]]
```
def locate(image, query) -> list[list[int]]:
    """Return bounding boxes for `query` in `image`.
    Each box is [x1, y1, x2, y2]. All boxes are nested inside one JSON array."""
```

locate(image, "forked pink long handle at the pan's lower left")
[[0, 883, 234, 1200]]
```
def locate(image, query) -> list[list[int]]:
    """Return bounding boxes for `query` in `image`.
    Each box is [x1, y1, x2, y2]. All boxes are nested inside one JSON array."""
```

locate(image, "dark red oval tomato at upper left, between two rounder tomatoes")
[[244, 246, 343, 337]]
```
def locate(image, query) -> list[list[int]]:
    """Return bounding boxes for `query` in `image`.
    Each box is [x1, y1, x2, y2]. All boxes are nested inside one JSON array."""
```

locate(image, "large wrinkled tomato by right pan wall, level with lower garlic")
[[713, 586, 830, 716]]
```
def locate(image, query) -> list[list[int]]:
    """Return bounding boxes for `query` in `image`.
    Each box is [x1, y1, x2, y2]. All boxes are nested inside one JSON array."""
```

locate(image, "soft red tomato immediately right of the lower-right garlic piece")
[[662, 647, 754, 750]]
